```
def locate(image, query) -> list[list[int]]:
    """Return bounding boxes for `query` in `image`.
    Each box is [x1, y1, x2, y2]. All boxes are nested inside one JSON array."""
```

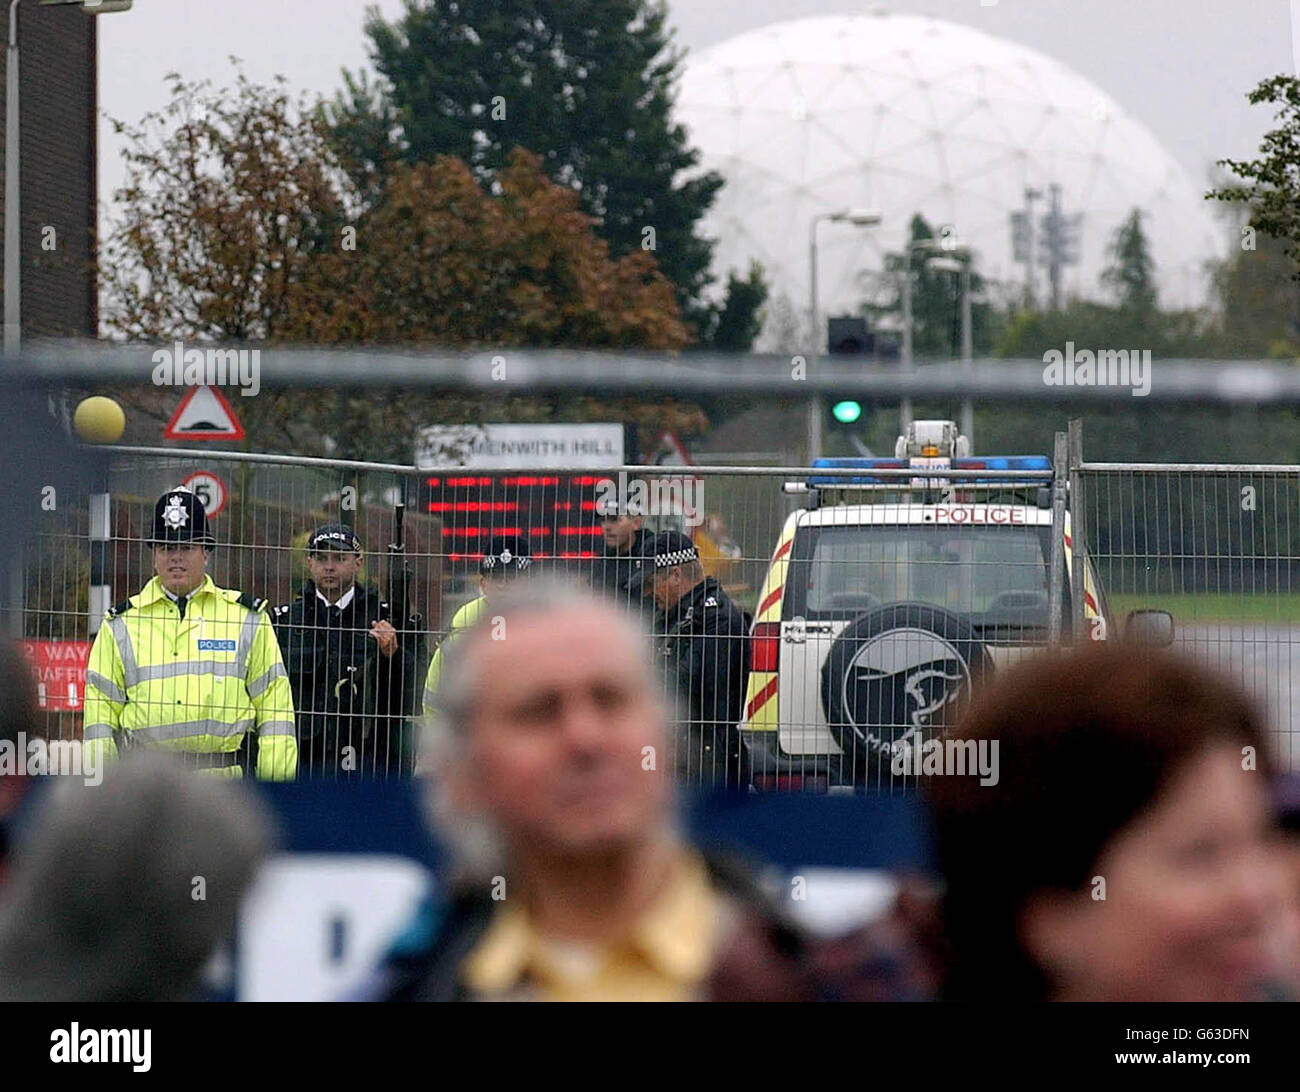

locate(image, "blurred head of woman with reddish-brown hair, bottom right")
[[928, 644, 1283, 1001]]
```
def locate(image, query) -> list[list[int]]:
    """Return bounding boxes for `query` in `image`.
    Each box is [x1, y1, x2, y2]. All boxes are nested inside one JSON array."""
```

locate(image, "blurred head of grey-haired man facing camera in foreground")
[[430, 580, 671, 875]]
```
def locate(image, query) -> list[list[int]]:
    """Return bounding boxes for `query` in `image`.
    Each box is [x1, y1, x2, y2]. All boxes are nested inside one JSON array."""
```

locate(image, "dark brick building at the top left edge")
[[0, 0, 99, 338]]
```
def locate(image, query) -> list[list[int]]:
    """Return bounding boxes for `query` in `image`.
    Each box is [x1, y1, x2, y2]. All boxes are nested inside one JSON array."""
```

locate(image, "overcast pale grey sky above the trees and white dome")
[[99, 0, 1300, 224]]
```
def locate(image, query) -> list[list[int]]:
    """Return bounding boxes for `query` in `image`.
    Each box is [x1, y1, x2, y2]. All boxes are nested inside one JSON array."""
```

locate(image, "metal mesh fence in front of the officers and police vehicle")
[[21, 450, 1300, 790]]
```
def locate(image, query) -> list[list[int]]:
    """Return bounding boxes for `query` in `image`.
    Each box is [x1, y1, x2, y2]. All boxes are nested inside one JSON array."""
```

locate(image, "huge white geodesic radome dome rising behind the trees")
[[676, 13, 1223, 347]]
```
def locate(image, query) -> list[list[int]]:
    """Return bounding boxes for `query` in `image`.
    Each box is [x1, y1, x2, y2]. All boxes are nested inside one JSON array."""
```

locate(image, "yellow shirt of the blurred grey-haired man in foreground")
[[462, 853, 723, 1001]]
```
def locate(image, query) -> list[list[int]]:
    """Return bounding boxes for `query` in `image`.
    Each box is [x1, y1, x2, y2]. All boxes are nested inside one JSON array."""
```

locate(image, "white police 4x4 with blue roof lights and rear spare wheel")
[[741, 421, 1173, 790]]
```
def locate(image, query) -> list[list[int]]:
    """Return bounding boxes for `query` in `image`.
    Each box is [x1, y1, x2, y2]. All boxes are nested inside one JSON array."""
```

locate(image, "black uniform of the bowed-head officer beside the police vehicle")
[[655, 576, 749, 787]]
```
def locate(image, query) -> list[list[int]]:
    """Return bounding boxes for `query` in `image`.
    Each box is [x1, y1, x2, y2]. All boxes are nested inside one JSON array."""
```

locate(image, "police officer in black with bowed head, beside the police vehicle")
[[631, 530, 749, 785]]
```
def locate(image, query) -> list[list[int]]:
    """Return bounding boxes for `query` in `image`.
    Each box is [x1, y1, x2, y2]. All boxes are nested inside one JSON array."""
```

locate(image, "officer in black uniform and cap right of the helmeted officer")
[[276, 523, 419, 777]]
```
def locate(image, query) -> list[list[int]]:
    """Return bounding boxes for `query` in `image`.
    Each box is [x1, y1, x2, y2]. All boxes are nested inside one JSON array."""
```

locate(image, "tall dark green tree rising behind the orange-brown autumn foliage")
[[329, 0, 762, 347]]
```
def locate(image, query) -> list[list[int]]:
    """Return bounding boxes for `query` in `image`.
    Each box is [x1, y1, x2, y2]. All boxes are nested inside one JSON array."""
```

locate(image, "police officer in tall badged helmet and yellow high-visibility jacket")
[[83, 489, 298, 781]]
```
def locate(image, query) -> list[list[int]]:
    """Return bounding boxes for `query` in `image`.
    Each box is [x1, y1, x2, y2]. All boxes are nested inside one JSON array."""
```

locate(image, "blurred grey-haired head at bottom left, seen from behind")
[[0, 753, 272, 1001]]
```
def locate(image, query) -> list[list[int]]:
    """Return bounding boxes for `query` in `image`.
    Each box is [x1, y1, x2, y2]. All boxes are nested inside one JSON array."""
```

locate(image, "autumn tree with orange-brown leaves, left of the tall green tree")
[[101, 73, 703, 462]]
